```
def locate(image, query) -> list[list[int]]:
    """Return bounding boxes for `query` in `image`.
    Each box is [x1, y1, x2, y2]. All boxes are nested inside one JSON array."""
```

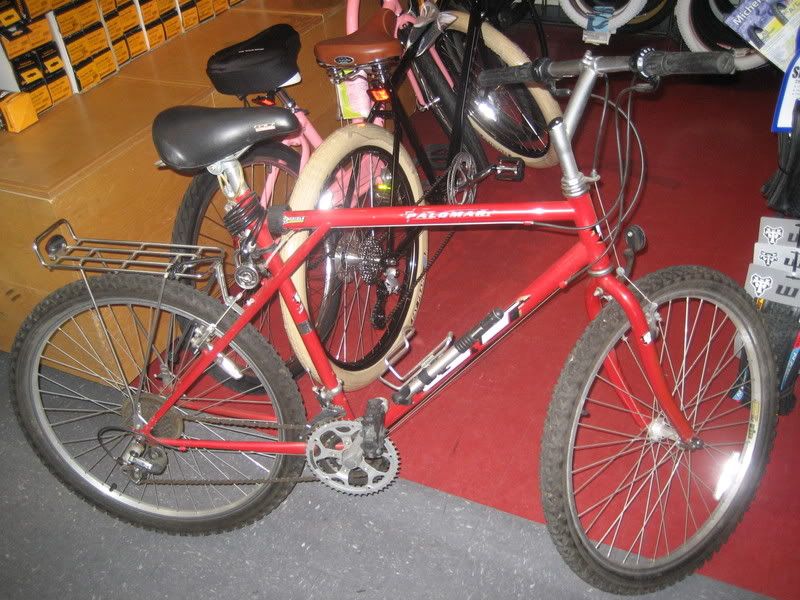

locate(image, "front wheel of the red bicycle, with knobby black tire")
[[541, 267, 777, 594]]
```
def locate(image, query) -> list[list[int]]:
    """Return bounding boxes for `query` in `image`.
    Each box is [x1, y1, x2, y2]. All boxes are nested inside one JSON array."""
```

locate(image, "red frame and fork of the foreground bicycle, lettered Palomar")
[[140, 194, 694, 454]]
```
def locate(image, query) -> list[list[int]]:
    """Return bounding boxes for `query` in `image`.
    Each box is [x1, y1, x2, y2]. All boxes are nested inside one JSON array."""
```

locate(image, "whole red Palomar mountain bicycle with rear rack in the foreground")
[[11, 51, 777, 594]]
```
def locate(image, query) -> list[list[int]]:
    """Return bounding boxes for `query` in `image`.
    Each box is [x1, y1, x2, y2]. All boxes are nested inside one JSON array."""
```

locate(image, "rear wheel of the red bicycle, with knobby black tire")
[[10, 275, 305, 534]]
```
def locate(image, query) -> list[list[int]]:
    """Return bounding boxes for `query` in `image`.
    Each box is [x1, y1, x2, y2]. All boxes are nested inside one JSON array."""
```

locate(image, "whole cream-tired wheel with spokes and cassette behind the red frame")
[[281, 125, 428, 389]]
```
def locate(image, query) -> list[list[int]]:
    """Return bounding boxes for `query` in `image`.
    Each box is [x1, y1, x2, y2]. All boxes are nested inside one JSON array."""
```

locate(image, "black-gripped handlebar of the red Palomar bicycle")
[[477, 48, 736, 87]]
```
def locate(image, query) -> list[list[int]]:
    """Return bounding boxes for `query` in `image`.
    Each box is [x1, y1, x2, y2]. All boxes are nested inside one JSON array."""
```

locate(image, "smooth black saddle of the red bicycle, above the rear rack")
[[153, 106, 300, 171]]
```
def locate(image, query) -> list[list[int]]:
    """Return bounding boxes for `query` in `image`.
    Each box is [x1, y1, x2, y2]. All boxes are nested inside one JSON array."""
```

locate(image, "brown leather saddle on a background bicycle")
[[314, 8, 403, 68]]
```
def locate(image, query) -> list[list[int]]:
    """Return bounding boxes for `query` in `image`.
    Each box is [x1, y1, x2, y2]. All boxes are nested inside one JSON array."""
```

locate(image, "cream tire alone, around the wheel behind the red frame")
[[281, 124, 428, 390]]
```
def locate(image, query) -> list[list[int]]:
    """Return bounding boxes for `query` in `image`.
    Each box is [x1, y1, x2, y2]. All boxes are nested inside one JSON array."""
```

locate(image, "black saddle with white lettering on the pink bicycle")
[[206, 23, 300, 96]]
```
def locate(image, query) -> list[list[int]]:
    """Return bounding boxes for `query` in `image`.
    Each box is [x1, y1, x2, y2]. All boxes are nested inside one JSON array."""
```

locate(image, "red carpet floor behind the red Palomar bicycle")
[[322, 41, 800, 598]]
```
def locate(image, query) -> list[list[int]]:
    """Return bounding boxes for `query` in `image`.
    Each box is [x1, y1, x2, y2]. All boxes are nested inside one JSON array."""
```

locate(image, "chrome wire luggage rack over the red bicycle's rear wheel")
[[33, 219, 225, 280]]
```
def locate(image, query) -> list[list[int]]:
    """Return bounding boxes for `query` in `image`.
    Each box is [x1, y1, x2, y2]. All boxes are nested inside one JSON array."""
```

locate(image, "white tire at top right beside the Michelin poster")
[[675, 0, 767, 71]]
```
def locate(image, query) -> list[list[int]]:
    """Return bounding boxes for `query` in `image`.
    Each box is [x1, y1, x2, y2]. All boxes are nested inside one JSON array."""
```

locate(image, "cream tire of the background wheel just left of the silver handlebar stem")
[[434, 11, 562, 168]]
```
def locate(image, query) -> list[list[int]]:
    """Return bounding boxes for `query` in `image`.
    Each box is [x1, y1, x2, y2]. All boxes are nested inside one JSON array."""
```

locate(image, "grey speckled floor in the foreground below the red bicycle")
[[0, 353, 763, 600]]
